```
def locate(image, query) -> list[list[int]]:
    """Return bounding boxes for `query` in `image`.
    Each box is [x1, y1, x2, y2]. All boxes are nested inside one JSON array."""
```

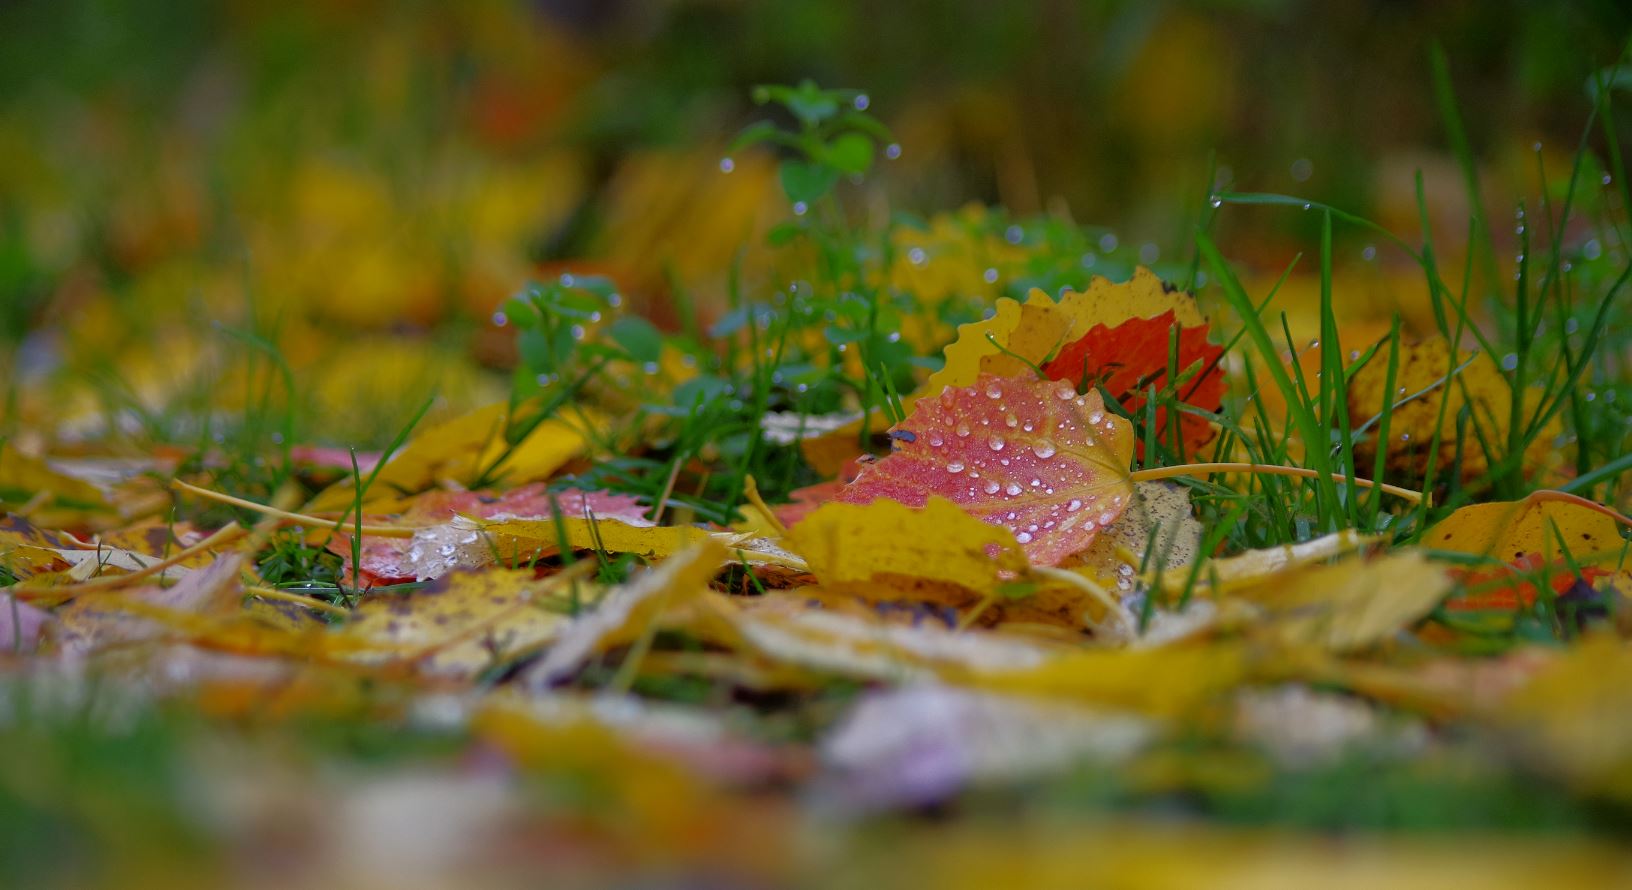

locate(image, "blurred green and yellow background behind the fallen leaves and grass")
[[0, 0, 1632, 438]]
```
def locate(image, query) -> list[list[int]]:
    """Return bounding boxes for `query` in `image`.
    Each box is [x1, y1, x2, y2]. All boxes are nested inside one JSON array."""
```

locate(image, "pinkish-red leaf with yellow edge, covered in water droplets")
[[837, 374, 1133, 565]]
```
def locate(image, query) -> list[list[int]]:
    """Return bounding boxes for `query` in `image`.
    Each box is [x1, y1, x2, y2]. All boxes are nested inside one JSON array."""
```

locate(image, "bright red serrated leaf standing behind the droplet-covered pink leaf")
[[1043, 310, 1224, 449]]
